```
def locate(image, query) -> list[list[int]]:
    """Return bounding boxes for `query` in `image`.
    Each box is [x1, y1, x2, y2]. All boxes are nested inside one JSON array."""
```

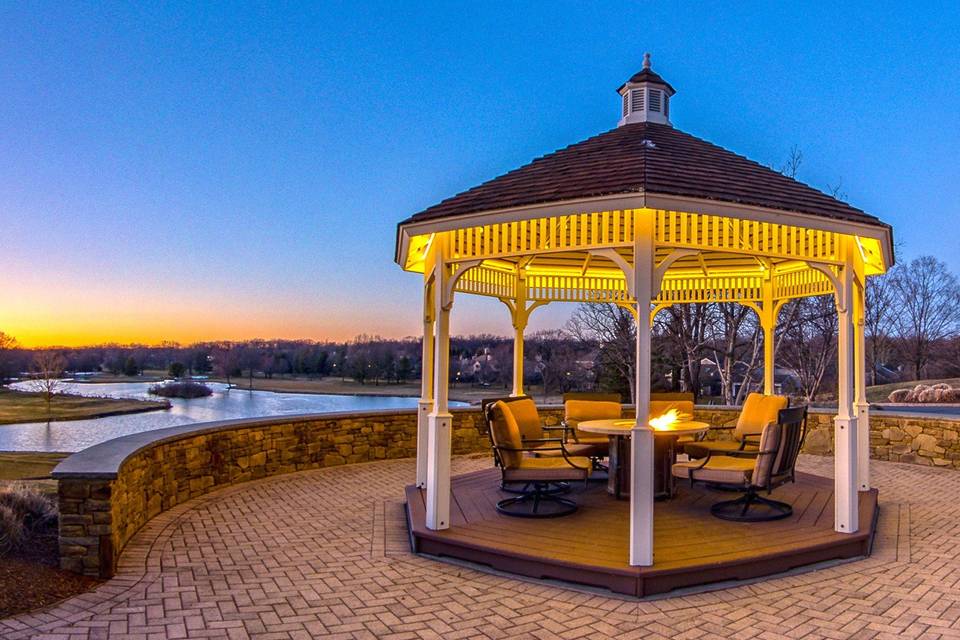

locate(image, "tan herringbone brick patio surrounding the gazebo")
[[0, 457, 960, 640]]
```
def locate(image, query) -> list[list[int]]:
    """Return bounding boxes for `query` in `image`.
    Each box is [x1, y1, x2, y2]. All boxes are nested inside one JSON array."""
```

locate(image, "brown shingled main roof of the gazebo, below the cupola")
[[402, 122, 887, 227]]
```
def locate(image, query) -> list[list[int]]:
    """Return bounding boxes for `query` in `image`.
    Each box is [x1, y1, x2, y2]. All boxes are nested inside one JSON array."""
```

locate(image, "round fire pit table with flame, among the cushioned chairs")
[[577, 419, 710, 500]]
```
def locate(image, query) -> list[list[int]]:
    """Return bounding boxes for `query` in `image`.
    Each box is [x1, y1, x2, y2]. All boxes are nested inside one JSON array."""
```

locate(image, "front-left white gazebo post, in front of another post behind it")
[[427, 236, 453, 531]]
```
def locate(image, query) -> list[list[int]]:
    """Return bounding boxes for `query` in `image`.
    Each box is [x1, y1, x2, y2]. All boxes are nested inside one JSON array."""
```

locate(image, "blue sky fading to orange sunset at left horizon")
[[0, 2, 960, 346]]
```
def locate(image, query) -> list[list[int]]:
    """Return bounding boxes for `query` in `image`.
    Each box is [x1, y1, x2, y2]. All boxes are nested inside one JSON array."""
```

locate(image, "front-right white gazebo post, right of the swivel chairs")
[[833, 252, 860, 533]]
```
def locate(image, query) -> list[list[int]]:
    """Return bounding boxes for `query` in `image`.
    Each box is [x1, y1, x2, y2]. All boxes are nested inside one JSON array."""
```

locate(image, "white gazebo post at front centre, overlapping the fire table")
[[630, 210, 655, 567]]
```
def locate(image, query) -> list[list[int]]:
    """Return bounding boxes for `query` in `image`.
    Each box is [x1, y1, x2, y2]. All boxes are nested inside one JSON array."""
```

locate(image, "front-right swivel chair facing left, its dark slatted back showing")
[[672, 407, 807, 522]]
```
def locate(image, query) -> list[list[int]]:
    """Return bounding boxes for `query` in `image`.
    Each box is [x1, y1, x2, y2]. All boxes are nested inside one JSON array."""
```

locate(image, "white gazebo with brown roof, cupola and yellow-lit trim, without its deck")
[[396, 54, 894, 567]]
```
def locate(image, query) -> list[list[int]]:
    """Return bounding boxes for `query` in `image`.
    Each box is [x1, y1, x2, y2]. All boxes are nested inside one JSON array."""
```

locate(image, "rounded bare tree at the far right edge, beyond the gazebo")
[[890, 256, 960, 380]]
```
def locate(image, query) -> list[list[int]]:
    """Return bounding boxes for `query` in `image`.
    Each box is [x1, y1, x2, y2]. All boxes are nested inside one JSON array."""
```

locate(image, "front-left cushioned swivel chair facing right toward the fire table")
[[487, 400, 592, 518]]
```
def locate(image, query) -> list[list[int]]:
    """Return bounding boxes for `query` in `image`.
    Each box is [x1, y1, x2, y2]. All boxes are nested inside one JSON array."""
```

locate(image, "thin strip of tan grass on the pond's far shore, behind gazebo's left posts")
[[211, 377, 561, 404]]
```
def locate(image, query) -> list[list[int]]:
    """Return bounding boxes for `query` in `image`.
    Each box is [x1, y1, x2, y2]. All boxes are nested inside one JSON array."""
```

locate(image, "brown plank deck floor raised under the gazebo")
[[406, 469, 877, 596]]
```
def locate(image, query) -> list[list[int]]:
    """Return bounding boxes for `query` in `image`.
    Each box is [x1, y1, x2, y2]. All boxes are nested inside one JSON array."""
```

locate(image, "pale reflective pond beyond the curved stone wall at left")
[[0, 382, 466, 451]]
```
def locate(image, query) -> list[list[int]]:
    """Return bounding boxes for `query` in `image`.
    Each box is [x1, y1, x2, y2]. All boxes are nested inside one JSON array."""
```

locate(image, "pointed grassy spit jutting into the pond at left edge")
[[0, 389, 170, 425]]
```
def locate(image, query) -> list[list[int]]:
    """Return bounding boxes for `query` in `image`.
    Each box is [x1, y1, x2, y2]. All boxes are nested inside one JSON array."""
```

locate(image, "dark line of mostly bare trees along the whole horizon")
[[0, 256, 960, 404]]
